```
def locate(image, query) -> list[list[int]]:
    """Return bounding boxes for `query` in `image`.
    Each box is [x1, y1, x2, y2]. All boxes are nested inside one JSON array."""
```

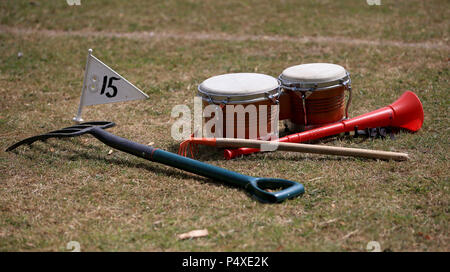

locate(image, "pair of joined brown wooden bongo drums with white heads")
[[198, 63, 352, 139]]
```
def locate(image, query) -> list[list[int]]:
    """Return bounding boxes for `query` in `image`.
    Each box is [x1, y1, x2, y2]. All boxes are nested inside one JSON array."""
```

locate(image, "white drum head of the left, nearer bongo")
[[198, 73, 280, 103]]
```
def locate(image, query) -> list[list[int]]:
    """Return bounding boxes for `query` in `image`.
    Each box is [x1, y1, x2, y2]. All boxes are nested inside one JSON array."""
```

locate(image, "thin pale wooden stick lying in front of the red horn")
[[216, 138, 409, 161]]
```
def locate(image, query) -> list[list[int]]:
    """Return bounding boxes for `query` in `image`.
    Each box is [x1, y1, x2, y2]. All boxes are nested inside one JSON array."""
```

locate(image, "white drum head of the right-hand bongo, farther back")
[[280, 63, 348, 84]]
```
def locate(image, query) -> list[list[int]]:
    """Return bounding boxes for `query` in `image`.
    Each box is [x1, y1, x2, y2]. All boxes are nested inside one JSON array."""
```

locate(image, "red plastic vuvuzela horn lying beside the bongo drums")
[[224, 91, 423, 159]]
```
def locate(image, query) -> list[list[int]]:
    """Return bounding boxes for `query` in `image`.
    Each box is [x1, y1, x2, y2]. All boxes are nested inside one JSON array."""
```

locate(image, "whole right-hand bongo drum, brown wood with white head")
[[279, 63, 352, 130]]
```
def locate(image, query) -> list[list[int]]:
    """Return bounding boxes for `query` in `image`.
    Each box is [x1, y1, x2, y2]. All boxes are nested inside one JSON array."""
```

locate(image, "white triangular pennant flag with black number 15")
[[74, 49, 148, 122]]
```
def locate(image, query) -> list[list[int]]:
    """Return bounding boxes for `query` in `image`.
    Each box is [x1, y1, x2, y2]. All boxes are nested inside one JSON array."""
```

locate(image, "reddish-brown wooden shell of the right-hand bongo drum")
[[284, 86, 346, 128]]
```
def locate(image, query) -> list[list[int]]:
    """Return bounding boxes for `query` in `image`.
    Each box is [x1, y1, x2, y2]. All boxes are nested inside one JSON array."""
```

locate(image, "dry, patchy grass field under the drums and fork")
[[0, 0, 450, 251]]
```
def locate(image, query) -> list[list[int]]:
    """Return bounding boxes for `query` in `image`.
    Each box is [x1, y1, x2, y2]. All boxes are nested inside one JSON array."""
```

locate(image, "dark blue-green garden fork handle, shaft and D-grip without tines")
[[89, 127, 305, 203]]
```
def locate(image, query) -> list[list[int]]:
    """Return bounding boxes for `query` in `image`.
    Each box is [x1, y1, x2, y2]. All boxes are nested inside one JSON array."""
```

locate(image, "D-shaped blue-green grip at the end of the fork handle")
[[245, 178, 305, 203]]
